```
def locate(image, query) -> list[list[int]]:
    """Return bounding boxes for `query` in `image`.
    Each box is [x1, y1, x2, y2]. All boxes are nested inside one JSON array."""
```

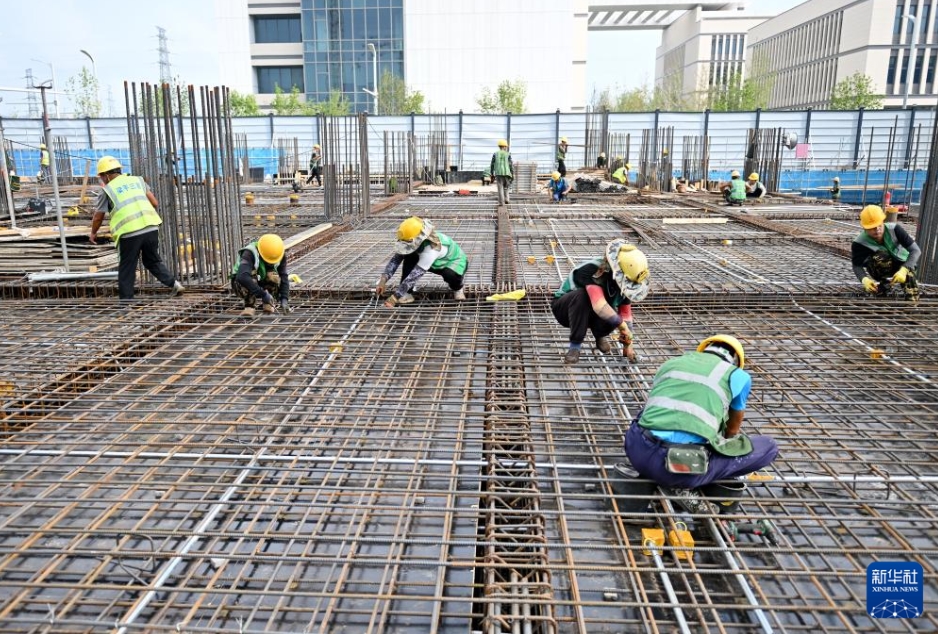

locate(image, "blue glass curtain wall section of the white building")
[[300, 0, 404, 112]]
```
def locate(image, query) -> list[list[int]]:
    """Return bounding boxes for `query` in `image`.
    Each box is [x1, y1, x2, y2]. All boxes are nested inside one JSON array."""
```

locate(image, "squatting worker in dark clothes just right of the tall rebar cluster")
[[230, 233, 293, 317]]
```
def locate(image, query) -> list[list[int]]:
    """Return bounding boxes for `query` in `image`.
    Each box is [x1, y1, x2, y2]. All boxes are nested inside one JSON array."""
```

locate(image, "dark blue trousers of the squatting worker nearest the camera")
[[625, 422, 778, 489]]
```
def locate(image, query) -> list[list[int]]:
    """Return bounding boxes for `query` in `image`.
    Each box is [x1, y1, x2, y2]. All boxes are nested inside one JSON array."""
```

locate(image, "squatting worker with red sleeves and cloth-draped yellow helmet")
[[550, 238, 648, 364]]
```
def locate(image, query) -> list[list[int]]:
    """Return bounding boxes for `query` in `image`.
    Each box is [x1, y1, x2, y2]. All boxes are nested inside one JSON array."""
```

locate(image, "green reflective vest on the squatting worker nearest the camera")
[[638, 352, 752, 456]]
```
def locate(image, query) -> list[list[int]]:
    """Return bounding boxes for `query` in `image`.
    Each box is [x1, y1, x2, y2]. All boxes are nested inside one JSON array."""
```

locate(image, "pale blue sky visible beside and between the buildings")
[[0, 0, 804, 117]]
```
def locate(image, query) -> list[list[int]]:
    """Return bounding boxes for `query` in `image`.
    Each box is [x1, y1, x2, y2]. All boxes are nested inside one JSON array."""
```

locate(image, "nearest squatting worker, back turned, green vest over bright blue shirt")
[[625, 335, 778, 514]]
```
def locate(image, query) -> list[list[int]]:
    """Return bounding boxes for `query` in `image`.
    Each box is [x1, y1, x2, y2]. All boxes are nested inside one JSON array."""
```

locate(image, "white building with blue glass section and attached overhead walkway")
[[216, 0, 742, 113]]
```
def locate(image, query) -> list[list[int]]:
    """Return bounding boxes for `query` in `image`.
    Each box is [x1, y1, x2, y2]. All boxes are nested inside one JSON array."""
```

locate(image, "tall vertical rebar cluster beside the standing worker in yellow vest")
[[124, 82, 243, 284]]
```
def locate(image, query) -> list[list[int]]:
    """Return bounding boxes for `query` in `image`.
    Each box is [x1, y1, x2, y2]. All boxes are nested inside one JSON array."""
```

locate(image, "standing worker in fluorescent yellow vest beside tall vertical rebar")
[[88, 156, 186, 300]]
